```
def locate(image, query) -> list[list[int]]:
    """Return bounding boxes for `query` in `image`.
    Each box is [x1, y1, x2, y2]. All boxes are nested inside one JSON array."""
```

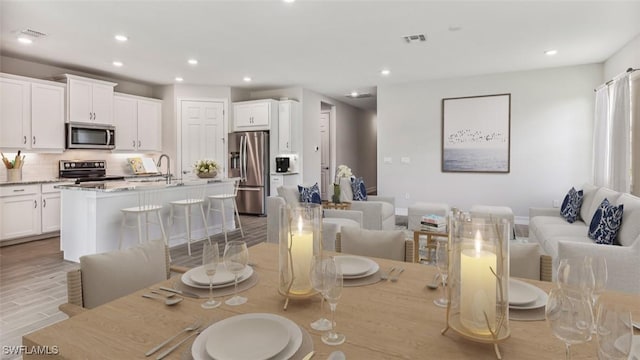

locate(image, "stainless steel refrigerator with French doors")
[[229, 131, 269, 215]]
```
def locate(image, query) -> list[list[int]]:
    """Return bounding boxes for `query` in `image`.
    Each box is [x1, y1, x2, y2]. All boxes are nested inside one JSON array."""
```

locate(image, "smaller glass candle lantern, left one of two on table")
[[279, 203, 322, 310]]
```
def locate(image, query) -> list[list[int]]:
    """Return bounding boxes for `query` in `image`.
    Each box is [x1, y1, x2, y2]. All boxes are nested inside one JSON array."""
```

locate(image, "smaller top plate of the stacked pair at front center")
[[206, 316, 290, 360]]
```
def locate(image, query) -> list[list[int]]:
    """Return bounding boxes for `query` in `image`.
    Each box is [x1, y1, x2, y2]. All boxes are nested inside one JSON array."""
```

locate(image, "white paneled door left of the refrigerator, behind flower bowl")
[[180, 100, 227, 176]]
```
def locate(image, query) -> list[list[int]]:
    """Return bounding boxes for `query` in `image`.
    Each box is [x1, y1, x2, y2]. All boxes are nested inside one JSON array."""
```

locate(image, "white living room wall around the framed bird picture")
[[377, 65, 603, 217]]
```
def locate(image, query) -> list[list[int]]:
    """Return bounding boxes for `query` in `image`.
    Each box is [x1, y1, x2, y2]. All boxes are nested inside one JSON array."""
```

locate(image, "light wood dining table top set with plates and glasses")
[[22, 243, 640, 360]]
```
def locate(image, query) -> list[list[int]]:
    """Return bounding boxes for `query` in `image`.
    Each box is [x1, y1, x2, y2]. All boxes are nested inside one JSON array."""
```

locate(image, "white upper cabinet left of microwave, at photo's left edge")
[[0, 74, 65, 152]]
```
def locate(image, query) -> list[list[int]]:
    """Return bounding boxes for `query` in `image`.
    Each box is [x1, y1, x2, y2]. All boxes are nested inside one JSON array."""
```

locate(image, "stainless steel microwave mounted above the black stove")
[[66, 122, 116, 150]]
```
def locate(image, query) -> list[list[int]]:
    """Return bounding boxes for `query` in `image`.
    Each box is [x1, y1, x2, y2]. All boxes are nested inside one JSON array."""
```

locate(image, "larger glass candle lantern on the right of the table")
[[442, 213, 511, 359]]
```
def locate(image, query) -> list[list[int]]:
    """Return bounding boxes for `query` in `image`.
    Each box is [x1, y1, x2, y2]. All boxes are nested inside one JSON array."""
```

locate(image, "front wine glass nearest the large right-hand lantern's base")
[[545, 288, 593, 360]]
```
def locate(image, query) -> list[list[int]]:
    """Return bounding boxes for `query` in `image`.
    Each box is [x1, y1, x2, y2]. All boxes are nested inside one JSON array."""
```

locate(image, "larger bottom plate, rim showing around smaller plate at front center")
[[191, 314, 302, 360]]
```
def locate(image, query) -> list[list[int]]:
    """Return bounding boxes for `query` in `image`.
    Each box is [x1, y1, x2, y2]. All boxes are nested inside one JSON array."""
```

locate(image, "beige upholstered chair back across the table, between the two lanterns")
[[336, 226, 415, 262]]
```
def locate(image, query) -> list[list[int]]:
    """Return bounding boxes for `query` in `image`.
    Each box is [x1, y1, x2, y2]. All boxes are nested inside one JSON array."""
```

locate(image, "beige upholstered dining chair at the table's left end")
[[59, 240, 186, 317]]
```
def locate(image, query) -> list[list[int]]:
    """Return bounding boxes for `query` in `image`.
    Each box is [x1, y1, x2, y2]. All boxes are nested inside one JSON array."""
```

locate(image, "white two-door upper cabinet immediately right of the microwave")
[[113, 93, 162, 151]]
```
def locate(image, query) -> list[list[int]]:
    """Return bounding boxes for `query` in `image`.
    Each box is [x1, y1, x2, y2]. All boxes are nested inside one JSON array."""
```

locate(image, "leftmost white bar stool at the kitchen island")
[[118, 189, 169, 249]]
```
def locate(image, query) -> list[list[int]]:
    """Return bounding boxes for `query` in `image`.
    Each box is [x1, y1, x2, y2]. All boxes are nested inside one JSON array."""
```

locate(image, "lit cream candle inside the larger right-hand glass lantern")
[[460, 231, 497, 335]]
